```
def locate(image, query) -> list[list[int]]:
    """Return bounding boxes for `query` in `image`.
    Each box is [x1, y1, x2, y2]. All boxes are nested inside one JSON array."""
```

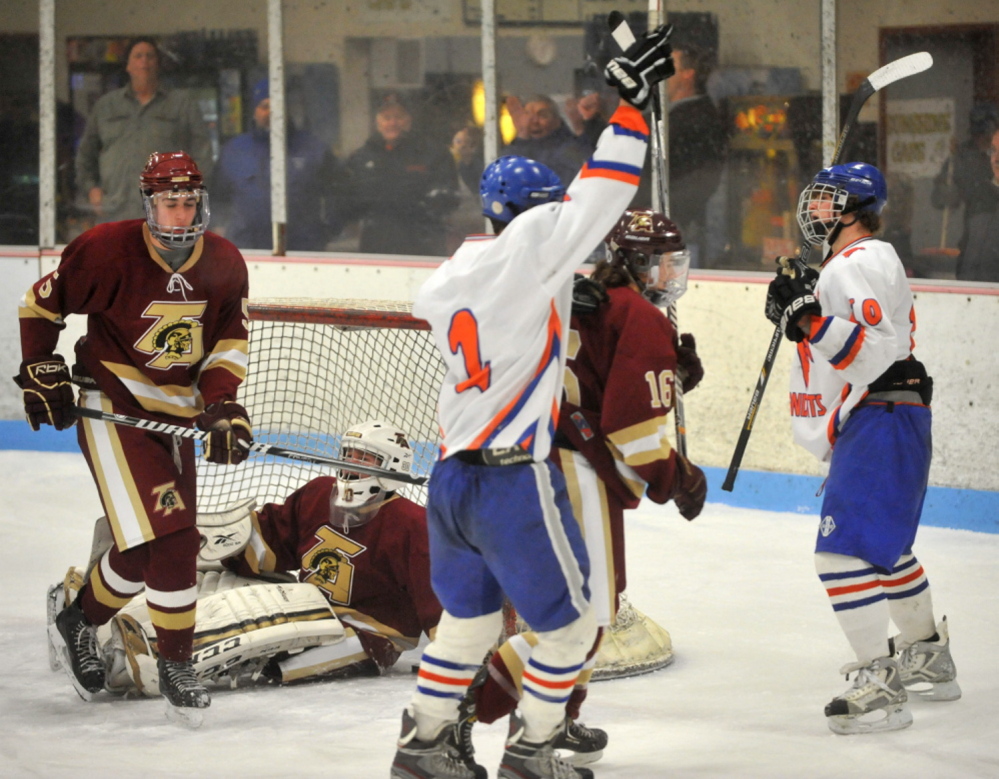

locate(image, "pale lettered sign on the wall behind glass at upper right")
[[887, 98, 954, 178]]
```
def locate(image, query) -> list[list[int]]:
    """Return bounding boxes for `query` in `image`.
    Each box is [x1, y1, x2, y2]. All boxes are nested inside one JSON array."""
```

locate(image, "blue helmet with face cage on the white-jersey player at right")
[[798, 162, 888, 246]]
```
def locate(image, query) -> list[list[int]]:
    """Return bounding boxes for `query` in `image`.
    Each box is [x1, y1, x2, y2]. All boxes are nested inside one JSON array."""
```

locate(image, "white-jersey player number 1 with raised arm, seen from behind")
[[392, 21, 673, 779]]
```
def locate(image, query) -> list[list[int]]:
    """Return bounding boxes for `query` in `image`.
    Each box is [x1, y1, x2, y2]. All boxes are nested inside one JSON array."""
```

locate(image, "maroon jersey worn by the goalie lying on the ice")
[[224, 477, 441, 648]]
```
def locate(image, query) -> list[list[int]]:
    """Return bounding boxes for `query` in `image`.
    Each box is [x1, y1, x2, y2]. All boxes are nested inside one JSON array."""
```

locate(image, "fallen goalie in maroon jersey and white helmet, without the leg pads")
[[223, 421, 441, 682]]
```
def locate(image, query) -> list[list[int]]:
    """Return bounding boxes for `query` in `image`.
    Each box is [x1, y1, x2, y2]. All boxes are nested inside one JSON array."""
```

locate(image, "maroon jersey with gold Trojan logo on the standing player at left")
[[18, 219, 248, 421]]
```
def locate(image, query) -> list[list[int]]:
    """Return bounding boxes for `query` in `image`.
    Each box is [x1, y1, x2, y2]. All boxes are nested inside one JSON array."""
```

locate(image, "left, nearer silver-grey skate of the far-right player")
[[826, 657, 912, 736]]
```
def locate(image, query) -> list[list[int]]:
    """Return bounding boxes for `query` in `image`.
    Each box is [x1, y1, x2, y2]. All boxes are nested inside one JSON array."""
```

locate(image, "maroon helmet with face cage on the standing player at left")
[[139, 151, 211, 249]]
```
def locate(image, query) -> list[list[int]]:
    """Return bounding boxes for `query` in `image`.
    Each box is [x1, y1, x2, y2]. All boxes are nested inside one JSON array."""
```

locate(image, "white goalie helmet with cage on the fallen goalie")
[[333, 420, 413, 509]]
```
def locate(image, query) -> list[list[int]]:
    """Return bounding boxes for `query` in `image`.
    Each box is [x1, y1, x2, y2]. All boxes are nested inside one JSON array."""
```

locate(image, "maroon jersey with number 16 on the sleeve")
[[559, 287, 677, 508]]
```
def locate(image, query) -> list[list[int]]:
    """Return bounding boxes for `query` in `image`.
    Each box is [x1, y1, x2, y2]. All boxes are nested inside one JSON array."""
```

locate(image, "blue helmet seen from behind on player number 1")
[[479, 156, 565, 222]]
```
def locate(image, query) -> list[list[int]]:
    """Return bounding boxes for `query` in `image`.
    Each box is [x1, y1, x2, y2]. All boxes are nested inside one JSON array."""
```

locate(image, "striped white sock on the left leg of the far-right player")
[[815, 552, 888, 664]]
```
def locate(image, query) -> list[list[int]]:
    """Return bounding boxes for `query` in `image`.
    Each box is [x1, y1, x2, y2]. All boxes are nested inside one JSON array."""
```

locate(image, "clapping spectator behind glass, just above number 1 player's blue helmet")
[[503, 95, 588, 182]]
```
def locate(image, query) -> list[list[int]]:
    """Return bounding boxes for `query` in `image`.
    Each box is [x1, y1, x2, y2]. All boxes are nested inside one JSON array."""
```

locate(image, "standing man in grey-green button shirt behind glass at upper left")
[[76, 38, 212, 222]]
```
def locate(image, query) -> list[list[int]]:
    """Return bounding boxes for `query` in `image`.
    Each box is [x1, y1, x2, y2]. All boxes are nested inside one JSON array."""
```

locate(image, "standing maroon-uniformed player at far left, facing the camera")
[[15, 152, 252, 726]]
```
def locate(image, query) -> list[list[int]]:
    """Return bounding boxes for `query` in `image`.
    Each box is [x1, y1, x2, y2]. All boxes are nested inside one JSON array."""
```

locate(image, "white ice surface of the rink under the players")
[[0, 451, 999, 779]]
